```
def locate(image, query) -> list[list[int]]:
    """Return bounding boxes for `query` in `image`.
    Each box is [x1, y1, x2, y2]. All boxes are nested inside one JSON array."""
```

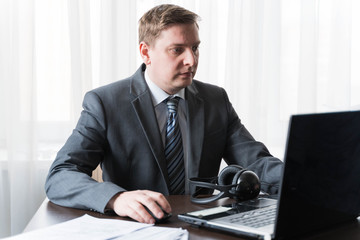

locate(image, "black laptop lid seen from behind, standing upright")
[[275, 111, 360, 239]]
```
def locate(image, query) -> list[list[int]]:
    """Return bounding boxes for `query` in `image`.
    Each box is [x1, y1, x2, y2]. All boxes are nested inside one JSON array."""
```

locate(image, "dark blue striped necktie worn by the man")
[[165, 97, 185, 195]]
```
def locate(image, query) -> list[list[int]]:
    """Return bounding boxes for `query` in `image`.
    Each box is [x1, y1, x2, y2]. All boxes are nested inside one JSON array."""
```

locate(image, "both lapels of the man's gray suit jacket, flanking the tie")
[[130, 65, 205, 193]]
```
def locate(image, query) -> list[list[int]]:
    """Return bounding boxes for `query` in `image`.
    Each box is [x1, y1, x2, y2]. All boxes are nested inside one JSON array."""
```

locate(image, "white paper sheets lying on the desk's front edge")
[[3, 215, 188, 240]]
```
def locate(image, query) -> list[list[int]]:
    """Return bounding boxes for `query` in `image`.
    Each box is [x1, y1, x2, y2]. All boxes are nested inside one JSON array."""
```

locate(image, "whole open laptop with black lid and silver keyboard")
[[178, 111, 360, 239]]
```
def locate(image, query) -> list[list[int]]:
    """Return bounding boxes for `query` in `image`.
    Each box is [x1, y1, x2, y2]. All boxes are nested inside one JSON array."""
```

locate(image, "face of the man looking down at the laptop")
[[140, 24, 200, 95]]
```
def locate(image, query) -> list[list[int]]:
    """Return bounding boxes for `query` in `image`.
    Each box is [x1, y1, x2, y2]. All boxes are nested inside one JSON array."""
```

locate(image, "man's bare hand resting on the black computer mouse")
[[106, 190, 171, 224]]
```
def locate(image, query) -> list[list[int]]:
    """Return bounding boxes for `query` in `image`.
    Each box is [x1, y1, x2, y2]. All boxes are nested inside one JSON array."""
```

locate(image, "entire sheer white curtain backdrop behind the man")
[[0, 0, 360, 237]]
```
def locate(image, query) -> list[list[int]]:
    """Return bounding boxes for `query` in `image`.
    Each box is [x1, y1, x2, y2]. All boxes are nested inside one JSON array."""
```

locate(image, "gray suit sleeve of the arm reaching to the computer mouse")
[[45, 92, 125, 212]]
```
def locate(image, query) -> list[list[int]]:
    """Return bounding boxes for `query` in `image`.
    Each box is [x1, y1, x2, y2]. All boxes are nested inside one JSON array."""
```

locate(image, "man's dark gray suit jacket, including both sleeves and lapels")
[[45, 65, 282, 212]]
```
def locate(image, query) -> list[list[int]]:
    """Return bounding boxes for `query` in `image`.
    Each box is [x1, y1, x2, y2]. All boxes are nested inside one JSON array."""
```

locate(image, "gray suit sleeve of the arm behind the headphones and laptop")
[[224, 91, 283, 194]]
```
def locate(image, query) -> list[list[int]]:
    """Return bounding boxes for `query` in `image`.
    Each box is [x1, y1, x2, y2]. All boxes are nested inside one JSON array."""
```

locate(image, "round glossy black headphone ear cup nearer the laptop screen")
[[231, 170, 261, 201]]
